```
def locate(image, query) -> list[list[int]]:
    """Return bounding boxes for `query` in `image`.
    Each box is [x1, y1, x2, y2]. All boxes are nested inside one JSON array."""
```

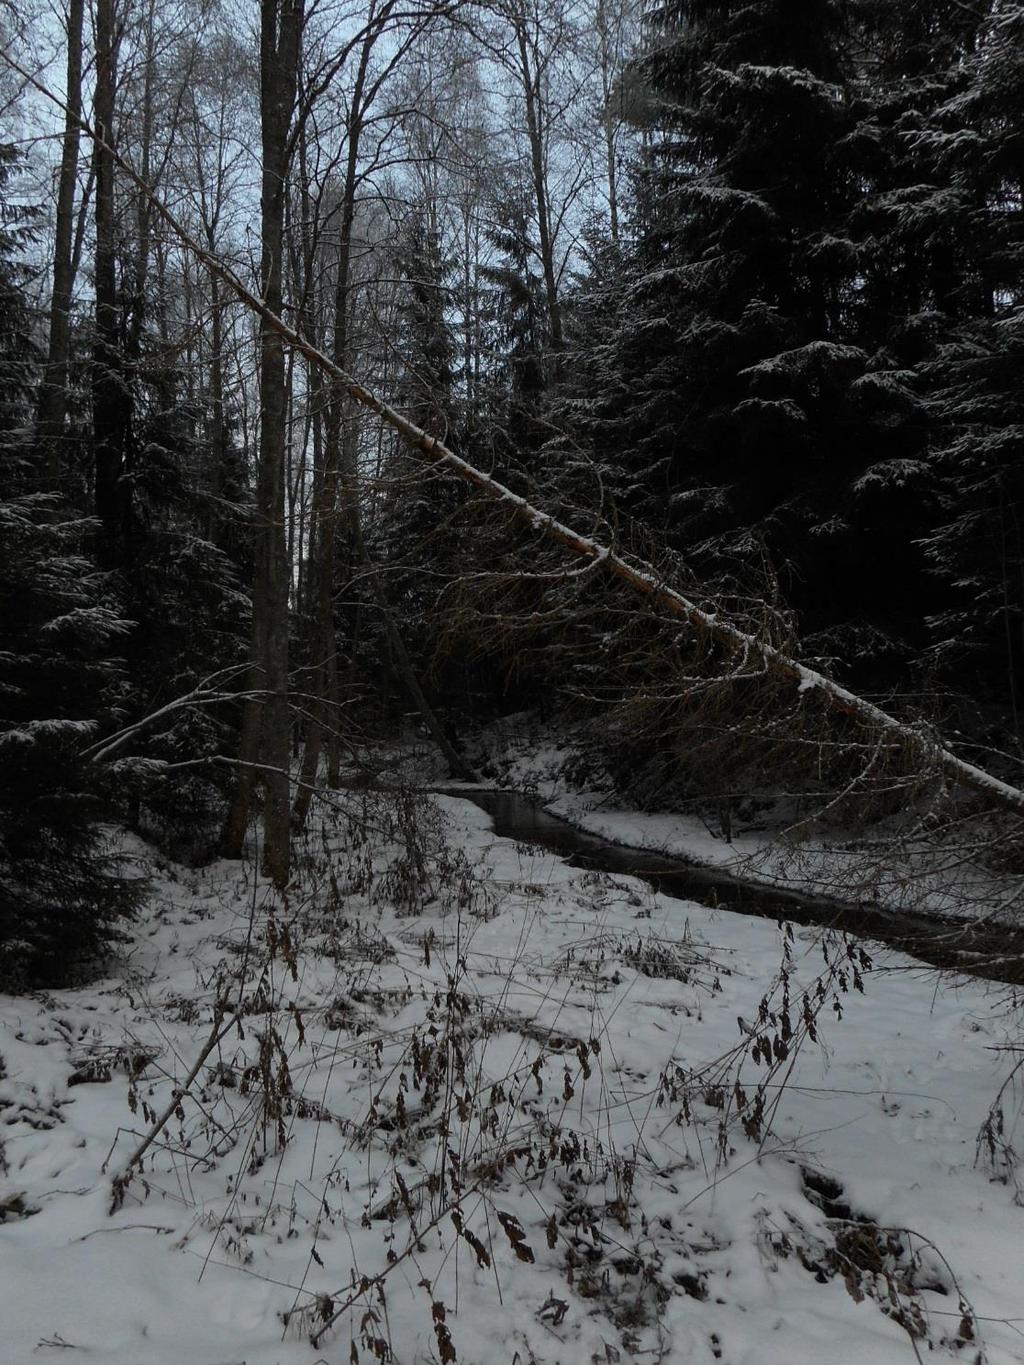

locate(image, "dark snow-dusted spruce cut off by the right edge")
[[919, 3, 1024, 747]]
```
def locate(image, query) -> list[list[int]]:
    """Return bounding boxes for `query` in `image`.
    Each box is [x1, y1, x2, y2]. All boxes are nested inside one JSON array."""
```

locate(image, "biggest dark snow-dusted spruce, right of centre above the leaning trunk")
[[570, 0, 944, 667]]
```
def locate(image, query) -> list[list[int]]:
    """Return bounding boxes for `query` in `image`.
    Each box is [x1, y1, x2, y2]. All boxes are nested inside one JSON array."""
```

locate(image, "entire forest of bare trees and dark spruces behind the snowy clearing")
[[0, 0, 1024, 984]]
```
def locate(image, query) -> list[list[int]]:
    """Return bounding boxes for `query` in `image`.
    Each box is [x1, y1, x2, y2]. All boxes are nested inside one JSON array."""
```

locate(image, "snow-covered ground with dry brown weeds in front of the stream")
[[0, 794, 1024, 1365]]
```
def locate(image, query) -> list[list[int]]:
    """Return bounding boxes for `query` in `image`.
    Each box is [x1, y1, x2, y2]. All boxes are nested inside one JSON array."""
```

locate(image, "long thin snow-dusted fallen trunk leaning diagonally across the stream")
[[10, 52, 1024, 815]]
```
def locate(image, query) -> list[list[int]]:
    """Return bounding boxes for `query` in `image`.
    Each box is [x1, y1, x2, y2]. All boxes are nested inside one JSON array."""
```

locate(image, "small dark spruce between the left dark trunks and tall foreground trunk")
[[111, 374, 250, 861]]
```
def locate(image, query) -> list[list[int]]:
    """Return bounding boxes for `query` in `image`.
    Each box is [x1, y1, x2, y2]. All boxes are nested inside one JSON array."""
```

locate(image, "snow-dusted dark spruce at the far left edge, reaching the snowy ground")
[[0, 147, 138, 991]]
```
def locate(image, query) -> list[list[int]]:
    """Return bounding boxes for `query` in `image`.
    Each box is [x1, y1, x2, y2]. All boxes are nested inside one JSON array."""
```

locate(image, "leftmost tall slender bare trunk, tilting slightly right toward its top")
[[35, 0, 85, 485]]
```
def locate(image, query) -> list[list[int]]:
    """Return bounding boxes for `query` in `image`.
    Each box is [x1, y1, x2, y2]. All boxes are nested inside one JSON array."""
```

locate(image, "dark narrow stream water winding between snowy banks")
[[438, 786, 1024, 984]]
